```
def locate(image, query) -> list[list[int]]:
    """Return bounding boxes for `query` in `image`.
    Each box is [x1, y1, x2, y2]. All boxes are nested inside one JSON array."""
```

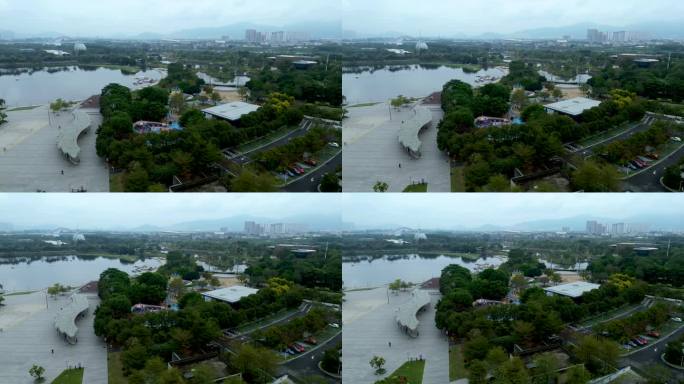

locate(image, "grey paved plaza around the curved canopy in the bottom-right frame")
[[342, 287, 449, 384]]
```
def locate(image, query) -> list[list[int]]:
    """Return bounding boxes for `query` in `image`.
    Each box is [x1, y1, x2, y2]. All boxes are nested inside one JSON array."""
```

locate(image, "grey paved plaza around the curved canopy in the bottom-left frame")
[[0, 291, 107, 384]]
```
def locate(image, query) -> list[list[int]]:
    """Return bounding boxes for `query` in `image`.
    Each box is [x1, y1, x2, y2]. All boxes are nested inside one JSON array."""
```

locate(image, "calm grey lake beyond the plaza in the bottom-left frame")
[[0, 256, 164, 292]]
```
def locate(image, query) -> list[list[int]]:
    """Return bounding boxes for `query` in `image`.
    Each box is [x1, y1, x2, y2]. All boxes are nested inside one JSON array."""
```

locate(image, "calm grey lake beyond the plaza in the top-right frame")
[[342, 65, 508, 105]]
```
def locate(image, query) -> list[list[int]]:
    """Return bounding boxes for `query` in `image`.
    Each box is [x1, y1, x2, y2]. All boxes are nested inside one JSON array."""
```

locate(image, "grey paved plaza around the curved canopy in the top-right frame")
[[342, 103, 451, 192]]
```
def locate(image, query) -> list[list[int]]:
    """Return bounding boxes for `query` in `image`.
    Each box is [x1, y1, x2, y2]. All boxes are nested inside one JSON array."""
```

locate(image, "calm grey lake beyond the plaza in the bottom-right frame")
[[342, 255, 507, 288]]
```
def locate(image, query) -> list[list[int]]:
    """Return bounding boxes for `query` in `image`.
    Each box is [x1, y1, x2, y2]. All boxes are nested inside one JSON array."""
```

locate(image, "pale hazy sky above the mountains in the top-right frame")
[[342, 0, 684, 36]]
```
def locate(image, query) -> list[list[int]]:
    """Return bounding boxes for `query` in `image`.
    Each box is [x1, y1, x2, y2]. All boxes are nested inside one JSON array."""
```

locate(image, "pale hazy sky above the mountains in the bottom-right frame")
[[342, 193, 684, 230]]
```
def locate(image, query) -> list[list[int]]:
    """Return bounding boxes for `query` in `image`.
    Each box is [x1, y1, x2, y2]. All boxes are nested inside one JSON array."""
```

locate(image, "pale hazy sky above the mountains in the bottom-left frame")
[[0, 193, 340, 229]]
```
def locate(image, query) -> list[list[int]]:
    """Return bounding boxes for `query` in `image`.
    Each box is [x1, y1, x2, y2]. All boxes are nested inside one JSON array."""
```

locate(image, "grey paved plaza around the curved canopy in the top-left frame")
[[0, 106, 109, 192]]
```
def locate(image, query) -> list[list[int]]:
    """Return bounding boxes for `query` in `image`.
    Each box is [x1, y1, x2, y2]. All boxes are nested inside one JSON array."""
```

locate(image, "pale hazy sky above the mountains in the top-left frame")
[[0, 0, 341, 36]]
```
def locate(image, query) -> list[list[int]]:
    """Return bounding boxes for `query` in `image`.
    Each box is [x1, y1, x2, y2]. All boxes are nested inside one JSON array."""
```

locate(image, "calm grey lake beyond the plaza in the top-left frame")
[[0, 66, 165, 107]]
